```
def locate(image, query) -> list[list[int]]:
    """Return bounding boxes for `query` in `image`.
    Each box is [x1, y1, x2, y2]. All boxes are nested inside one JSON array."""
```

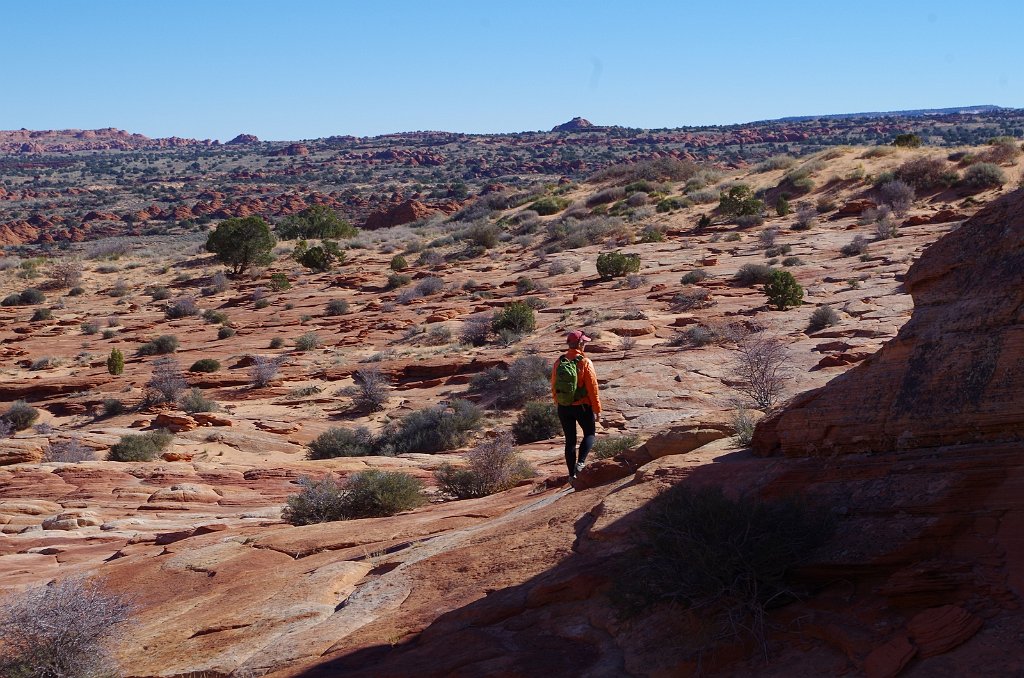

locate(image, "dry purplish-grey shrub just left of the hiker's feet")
[[434, 431, 536, 499]]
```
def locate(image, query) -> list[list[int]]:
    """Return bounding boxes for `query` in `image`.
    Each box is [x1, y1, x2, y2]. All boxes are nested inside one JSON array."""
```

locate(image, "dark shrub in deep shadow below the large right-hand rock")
[[612, 483, 834, 640]]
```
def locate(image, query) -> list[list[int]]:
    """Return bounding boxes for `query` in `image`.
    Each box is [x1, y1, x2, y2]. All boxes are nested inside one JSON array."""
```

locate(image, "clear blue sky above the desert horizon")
[[0, 0, 1024, 141]]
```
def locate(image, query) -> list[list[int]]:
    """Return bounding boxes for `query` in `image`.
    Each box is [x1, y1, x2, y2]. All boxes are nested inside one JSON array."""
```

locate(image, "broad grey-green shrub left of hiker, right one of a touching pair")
[[375, 399, 483, 454]]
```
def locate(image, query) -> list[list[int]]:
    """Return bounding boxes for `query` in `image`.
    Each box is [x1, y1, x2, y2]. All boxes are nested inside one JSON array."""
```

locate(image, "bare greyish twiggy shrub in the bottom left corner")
[[0, 576, 134, 678]]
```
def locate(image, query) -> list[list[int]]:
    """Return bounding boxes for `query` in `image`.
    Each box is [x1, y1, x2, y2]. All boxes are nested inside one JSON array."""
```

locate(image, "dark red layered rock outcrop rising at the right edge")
[[754, 190, 1024, 456]]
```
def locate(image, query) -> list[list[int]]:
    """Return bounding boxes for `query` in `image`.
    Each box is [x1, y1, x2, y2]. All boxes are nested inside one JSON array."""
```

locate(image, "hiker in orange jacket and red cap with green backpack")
[[551, 330, 601, 481]]
